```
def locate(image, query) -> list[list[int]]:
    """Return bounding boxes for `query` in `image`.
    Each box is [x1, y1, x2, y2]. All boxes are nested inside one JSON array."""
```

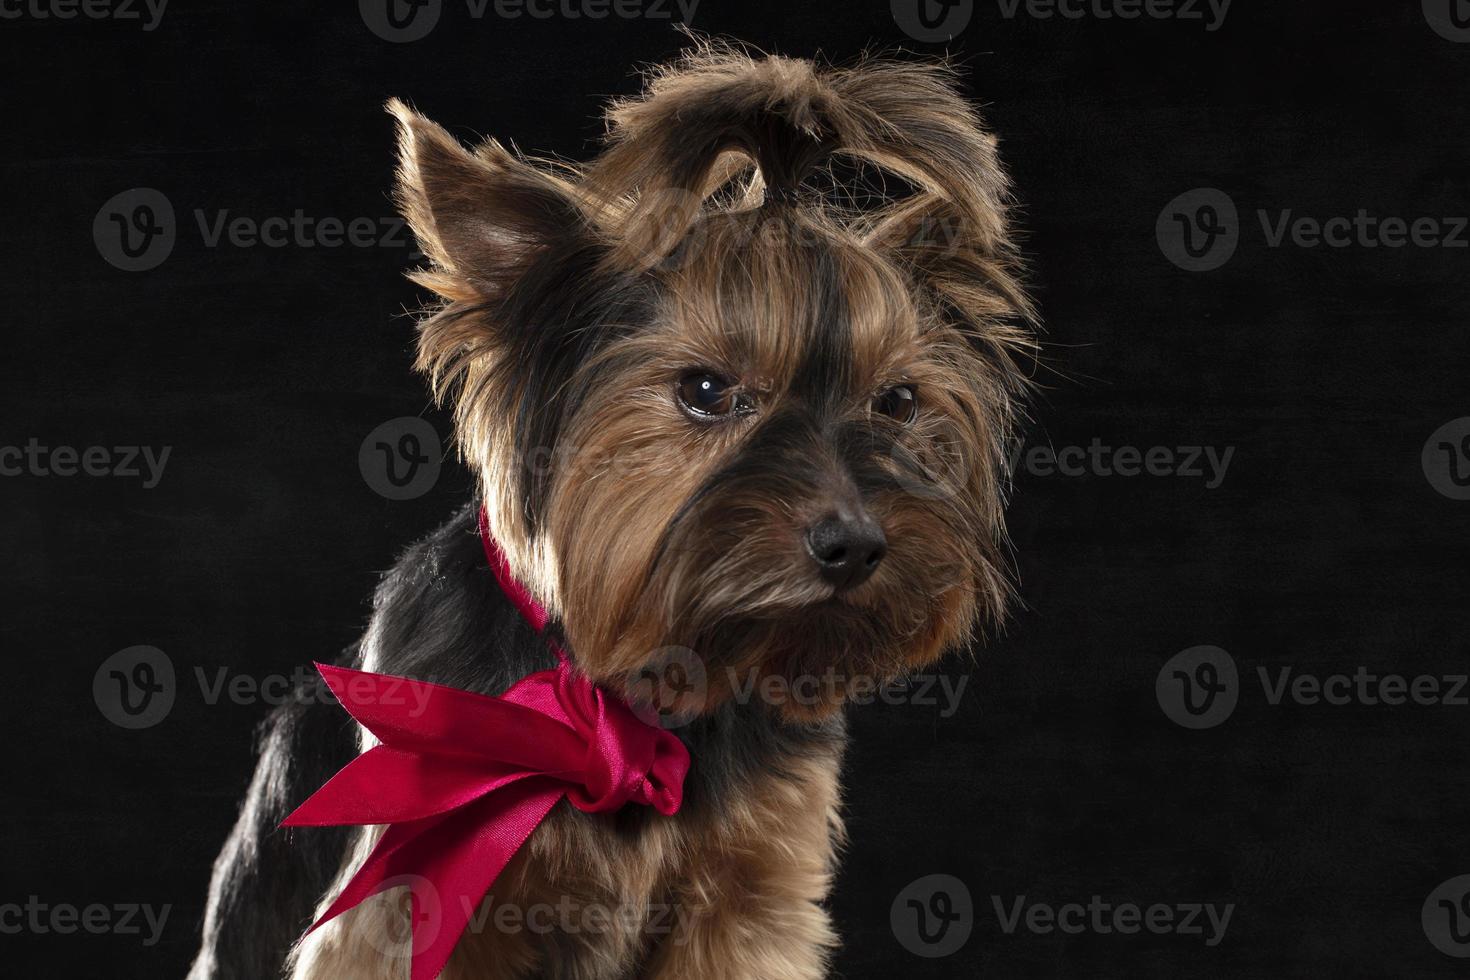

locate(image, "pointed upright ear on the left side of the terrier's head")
[[388, 98, 589, 303]]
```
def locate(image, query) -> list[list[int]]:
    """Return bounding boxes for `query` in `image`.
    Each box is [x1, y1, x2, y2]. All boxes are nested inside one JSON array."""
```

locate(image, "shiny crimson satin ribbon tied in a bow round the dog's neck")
[[282, 513, 689, 980]]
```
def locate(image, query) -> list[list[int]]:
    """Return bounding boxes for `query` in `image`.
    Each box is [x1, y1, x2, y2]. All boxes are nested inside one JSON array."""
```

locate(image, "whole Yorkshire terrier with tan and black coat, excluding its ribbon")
[[190, 40, 1036, 980]]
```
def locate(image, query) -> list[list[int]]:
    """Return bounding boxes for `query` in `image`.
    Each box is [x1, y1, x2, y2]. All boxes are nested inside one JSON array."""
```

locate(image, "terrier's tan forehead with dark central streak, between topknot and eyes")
[[669, 222, 919, 389]]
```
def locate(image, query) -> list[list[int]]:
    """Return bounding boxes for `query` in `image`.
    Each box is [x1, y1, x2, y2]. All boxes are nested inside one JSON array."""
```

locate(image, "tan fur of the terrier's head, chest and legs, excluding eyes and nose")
[[293, 36, 1035, 980]]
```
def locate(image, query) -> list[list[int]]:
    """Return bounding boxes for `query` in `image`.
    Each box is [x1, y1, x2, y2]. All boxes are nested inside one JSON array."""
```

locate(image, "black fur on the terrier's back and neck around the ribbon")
[[190, 507, 844, 980]]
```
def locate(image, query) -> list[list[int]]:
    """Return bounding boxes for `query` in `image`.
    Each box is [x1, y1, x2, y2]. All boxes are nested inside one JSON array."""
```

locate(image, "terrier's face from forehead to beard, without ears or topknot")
[[547, 210, 1003, 711]]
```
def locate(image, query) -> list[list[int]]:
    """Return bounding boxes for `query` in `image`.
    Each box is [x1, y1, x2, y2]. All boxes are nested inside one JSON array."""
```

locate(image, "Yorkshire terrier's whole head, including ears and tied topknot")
[[391, 44, 1032, 716]]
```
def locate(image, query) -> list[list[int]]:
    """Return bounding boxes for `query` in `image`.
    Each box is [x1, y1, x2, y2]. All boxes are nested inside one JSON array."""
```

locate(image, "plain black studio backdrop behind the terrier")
[[0, 0, 1470, 979]]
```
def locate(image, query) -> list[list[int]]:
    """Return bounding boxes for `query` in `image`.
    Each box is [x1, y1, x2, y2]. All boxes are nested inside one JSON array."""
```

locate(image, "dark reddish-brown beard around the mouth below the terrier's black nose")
[[625, 517, 976, 721]]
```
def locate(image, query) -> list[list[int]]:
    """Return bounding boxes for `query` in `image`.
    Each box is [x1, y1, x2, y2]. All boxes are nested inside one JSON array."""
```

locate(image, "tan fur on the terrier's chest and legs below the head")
[[288, 746, 842, 980]]
